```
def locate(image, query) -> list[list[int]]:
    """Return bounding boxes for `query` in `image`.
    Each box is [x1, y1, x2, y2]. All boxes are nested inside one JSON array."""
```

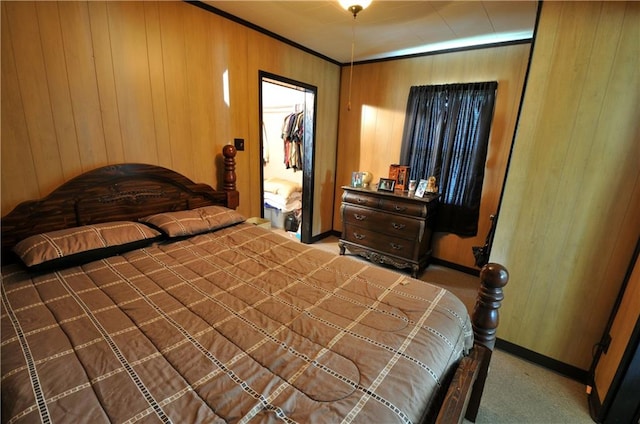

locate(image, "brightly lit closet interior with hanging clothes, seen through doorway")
[[261, 78, 306, 237]]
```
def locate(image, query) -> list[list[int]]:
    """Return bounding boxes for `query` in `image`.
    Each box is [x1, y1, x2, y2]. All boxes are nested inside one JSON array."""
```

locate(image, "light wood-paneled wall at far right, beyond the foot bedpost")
[[491, 1, 640, 370]]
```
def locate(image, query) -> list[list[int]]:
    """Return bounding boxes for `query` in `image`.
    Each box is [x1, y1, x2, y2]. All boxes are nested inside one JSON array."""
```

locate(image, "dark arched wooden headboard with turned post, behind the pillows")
[[1, 145, 239, 264]]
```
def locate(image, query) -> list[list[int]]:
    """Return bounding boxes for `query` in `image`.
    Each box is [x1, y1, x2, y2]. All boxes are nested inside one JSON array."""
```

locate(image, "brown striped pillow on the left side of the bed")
[[13, 221, 162, 270]]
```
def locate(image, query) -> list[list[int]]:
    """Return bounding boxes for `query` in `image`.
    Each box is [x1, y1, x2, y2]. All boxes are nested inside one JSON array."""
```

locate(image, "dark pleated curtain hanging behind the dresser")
[[400, 81, 498, 237]]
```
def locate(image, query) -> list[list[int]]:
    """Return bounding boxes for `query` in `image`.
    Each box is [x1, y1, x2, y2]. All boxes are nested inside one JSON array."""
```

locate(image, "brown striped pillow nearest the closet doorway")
[[140, 206, 245, 237]]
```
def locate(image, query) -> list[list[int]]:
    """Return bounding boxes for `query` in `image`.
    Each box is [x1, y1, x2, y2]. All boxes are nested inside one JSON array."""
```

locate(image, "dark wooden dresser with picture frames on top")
[[338, 186, 439, 277]]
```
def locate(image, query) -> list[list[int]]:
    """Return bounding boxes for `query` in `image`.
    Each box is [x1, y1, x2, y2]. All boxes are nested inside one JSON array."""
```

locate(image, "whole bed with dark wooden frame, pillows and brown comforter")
[[1, 146, 508, 423]]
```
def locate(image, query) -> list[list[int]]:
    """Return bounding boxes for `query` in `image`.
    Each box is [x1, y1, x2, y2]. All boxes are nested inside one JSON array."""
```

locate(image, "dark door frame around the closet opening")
[[258, 70, 318, 243]]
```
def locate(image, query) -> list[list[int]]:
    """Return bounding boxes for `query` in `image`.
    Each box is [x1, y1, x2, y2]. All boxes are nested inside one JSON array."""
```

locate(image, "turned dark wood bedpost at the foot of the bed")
[[465, 263, 509, 422]]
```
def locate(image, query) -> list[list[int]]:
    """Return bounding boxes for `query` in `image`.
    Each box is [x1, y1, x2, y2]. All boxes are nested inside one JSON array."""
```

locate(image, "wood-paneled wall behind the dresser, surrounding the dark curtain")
[[334, 43, 531, 267]]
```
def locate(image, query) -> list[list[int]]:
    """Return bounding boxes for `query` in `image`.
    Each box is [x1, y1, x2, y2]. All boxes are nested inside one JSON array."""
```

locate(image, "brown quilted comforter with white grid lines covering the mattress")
[[1, 223, 473, 423]]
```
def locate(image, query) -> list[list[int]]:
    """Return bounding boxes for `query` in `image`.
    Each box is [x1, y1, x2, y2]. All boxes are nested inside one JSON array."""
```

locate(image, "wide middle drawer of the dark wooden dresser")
[[342, 205, 424, 240]]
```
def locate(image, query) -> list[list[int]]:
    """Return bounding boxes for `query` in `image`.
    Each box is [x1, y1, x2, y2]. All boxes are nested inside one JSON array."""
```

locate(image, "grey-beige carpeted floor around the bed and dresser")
[[296, 234, 594, 424]]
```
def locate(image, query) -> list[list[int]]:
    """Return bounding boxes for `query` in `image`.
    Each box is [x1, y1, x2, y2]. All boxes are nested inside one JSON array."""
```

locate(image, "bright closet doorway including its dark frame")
[[259, 71, 317, 243]]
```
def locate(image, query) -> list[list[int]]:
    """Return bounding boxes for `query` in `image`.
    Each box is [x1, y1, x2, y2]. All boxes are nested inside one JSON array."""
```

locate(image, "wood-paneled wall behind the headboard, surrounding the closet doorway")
[[1, 1, 340, 234]]
